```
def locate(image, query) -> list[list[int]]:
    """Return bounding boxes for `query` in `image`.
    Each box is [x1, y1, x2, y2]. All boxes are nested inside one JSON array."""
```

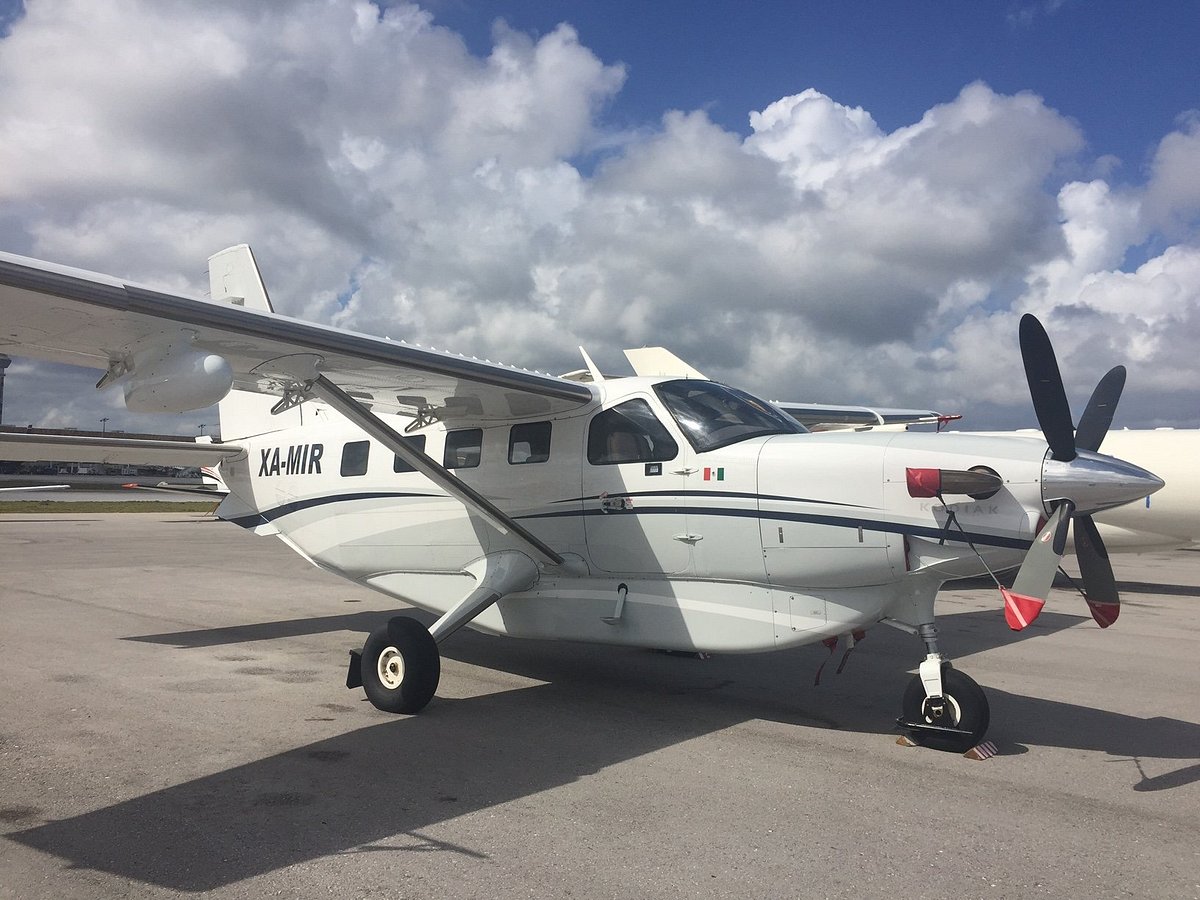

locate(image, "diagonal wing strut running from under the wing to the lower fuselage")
[[274, 370, 563, 565]]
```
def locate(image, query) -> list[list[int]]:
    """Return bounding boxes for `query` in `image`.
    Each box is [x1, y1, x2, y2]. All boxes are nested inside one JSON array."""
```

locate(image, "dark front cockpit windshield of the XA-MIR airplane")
[[654, 379, 805, 454]]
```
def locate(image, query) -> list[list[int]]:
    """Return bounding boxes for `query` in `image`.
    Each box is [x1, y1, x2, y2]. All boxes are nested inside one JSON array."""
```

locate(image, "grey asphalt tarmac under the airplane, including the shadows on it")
[[0, 514, 1200, 900]]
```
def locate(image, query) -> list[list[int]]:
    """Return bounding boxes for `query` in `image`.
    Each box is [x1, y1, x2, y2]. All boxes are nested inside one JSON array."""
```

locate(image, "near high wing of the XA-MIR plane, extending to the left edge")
[[0, 252, 594, 421]]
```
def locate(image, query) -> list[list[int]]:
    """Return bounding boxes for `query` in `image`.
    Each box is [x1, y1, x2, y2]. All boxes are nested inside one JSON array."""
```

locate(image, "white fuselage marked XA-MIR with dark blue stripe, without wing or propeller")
[[213, 378, 1070, 652]]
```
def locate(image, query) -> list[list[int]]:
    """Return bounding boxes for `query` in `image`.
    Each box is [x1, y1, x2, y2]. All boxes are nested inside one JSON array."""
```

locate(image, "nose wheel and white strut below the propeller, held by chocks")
[[888, 622, 991, 754]]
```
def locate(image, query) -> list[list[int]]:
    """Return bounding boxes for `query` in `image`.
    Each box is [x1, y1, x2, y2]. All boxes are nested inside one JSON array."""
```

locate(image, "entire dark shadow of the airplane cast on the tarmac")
[[6, 611, 1200, 892]]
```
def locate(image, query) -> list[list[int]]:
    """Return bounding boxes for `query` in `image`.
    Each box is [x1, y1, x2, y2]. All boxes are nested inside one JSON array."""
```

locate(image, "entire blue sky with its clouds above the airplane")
[[0, 0, 1200, 433]]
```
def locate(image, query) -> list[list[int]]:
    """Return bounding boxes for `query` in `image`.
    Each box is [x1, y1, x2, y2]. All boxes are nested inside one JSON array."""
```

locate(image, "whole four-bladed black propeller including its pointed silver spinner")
[[1001, 314, 1163, 631]]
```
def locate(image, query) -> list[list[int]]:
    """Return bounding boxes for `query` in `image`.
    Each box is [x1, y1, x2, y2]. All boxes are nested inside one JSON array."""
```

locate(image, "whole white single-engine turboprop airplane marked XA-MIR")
[[0, 245, 1162, 750]]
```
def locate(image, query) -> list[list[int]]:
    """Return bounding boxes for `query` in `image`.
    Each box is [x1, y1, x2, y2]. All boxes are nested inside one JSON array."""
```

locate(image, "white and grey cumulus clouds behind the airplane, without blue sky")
[[0, 0, 1200, 430]]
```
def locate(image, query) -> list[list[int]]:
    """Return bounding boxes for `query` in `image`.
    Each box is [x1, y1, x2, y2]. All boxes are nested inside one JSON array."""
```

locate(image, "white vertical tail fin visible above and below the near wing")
[[209, 244, 304, 440]]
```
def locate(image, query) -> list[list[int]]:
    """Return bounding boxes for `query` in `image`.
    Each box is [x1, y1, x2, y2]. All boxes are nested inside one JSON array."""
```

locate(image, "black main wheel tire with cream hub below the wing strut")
[[361, 616, 442, 715]]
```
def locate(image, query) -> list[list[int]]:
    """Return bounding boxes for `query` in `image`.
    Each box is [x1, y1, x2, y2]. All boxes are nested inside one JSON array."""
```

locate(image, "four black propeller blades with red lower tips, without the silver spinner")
[[1001, 314, 1126, 631]]
